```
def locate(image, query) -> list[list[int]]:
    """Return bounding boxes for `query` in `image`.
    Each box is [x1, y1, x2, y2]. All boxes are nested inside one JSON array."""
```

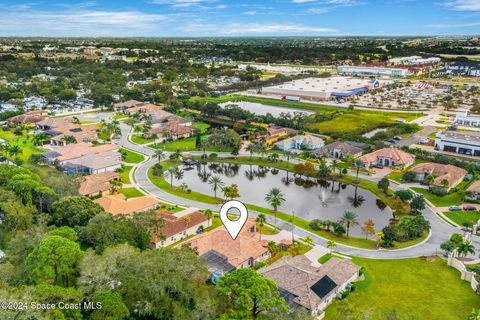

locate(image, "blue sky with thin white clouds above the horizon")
[[0, 0, 480, 37]]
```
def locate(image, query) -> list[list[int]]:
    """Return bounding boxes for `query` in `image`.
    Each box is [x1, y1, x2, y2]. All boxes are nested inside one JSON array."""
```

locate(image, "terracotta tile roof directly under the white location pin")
[[187, 219, 268, 267]]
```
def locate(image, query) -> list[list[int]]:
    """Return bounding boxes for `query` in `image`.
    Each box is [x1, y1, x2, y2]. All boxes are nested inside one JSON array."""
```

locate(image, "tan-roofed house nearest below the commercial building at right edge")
[[409, 162, 467, 191]]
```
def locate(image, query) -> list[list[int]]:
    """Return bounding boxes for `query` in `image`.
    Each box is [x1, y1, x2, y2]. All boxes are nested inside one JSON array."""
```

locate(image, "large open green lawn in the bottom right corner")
[[325, 258, 480, 320]]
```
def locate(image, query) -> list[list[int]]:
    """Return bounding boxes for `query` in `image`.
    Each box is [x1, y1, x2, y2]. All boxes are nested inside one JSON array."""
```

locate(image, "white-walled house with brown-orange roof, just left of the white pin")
[[152, 209, 208, 249]]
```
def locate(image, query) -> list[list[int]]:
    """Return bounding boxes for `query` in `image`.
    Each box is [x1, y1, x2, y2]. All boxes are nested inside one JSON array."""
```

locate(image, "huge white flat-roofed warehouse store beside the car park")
[[262, 77, 380, 101]]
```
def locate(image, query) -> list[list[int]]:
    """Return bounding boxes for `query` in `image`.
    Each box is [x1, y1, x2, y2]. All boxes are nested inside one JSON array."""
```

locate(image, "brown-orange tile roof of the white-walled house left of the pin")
[[153, 211, 208, 242]]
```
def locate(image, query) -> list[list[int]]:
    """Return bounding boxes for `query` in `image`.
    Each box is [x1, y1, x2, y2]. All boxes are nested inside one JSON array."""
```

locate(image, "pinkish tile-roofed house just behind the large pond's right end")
[[358, 148, 415, 168]]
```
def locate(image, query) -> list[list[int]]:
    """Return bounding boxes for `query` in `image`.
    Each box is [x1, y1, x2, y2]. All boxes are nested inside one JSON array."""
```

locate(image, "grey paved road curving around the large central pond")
[[117, 124, 480, 259]]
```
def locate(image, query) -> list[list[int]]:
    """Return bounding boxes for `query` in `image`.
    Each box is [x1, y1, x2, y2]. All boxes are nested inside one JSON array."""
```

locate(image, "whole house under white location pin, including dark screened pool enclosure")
[[186, 219, 271, 273]]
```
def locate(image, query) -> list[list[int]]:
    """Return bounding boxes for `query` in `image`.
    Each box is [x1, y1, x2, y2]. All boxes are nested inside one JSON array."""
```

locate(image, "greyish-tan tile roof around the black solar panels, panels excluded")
[[258, 255, 360, 310]]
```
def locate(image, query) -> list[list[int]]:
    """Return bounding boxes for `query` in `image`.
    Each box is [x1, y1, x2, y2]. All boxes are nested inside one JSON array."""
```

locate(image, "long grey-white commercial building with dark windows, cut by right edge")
[[435, 131, 480, 157]]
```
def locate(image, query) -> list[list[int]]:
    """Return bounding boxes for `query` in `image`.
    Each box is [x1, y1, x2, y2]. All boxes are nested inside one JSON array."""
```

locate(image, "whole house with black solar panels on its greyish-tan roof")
[[258, 255, 360, 319]]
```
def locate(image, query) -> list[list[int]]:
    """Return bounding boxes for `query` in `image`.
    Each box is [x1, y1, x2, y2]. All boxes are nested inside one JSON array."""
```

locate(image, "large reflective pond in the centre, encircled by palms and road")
[[178, 163, 392, 236]]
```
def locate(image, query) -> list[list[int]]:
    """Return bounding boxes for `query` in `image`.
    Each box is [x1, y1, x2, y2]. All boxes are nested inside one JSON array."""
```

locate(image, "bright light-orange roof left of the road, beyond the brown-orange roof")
[[94, 194, 158, 215]]
